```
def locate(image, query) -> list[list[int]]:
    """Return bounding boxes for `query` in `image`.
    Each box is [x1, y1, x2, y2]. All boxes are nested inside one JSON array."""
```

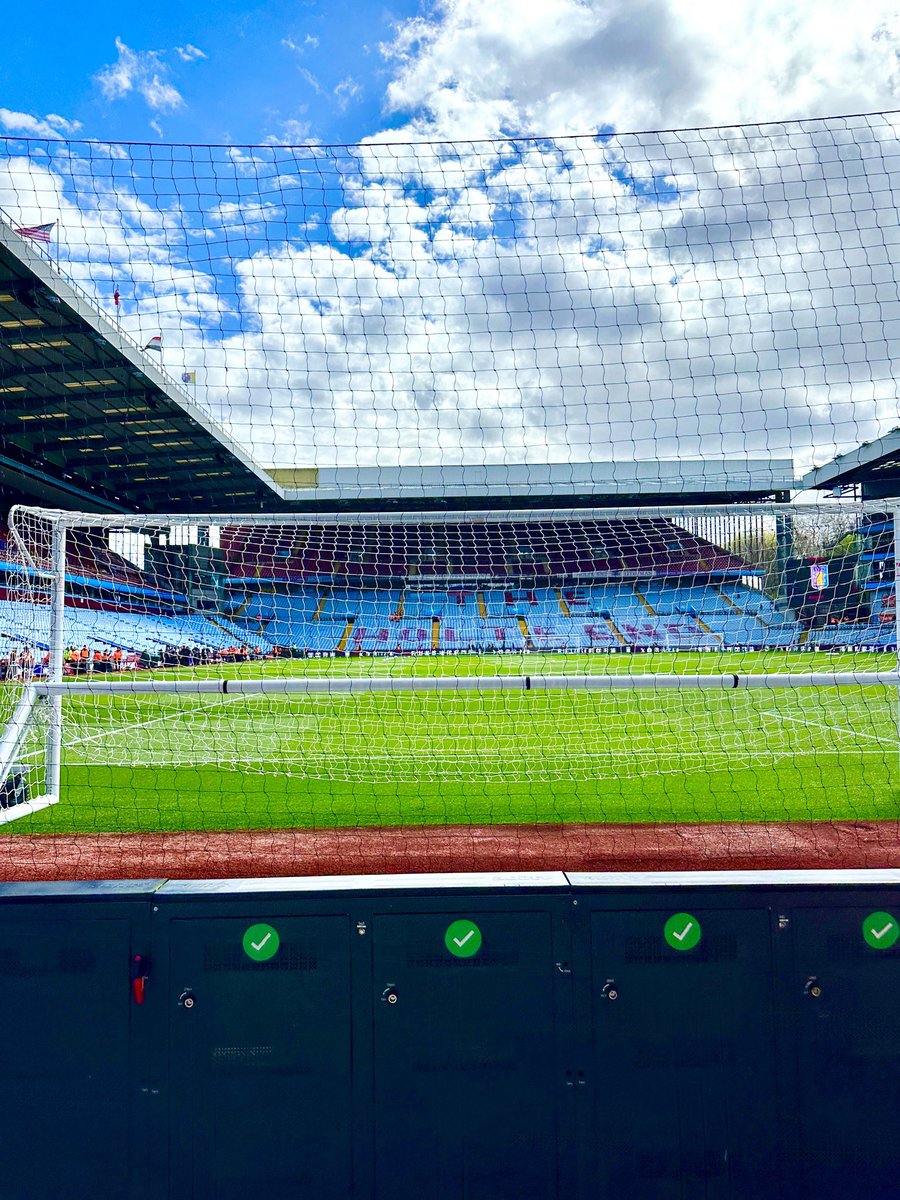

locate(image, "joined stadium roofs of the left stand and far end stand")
[[0, 218, 797, 512]]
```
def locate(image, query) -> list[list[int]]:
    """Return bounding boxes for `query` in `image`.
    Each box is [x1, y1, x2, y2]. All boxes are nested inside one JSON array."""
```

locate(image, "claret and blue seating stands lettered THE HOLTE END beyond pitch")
[[10, 504, 895, 661]]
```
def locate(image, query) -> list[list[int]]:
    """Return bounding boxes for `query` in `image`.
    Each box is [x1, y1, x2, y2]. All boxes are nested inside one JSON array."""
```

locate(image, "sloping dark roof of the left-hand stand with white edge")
[[0, 221, 278, 511]]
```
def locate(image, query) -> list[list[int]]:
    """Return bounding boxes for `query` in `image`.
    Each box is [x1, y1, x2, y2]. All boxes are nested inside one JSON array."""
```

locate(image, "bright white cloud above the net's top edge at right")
[[382, 0, 900, 137]]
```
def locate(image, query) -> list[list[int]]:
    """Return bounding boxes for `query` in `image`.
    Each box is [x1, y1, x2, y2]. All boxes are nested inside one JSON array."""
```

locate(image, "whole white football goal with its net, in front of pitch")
[[0, 503, 900, 832]]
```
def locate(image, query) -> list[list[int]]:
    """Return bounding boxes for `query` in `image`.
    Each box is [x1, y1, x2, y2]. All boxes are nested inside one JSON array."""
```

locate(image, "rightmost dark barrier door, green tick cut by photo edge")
[[782, 889, 900, 1200]]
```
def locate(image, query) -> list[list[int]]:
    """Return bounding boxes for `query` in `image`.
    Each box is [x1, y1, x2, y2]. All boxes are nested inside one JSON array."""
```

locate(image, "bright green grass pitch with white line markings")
[[2, 652, 900, 834]]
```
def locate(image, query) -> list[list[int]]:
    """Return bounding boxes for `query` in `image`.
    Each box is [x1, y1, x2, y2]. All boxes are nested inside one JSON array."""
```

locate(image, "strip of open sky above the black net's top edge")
[[0, 0, 900, 144]]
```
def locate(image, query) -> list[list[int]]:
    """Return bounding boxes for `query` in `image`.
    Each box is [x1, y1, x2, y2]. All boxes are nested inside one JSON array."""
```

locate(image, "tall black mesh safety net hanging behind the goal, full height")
[[0, 113, 900, 874]]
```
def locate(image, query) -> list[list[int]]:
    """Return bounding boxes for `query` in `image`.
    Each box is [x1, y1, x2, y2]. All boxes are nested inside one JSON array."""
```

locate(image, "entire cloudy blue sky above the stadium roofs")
[[0, 0, 900, 477]]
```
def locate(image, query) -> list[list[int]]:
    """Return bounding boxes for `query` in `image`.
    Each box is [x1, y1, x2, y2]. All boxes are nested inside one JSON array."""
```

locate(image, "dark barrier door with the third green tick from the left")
[[586, 895, 776, 1200]]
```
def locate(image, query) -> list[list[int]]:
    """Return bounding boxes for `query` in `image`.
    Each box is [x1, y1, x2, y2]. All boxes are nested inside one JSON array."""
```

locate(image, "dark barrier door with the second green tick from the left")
[[372, 895, 562, 1200]]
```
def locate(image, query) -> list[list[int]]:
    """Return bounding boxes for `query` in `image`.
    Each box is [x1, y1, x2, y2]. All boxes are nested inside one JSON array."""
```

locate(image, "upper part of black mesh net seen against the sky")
[[0, 113, 900, 477]]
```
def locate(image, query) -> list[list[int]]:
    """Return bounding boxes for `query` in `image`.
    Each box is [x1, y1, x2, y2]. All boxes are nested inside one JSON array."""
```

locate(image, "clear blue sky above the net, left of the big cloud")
[[0, 0, 419, 143]]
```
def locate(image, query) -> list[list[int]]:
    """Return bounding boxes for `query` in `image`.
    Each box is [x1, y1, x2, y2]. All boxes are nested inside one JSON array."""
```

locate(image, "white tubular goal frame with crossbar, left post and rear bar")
[[0, 500, 900, 824]]
